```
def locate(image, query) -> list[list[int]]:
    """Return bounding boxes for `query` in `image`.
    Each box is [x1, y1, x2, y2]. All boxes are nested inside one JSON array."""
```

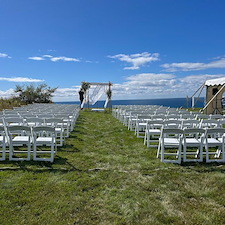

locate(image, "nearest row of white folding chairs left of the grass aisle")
[[0, 126, 57, 162]]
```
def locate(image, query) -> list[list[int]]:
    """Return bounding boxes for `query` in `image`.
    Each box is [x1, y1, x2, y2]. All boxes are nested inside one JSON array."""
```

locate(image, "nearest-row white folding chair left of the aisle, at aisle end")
[[33, 126, 57, 162]]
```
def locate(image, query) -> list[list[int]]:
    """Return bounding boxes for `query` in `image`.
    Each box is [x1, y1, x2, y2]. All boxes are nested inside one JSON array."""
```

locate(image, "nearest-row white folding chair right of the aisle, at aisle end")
[[157, 128, 184, 164]]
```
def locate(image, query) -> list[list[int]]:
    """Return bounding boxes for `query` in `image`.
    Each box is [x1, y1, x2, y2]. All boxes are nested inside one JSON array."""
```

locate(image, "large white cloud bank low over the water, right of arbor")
[[112, 73, 225, 99]]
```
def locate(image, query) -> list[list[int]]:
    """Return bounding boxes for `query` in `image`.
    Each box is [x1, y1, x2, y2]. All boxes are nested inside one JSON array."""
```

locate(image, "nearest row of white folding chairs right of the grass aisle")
[[157, 128, 225, 164]]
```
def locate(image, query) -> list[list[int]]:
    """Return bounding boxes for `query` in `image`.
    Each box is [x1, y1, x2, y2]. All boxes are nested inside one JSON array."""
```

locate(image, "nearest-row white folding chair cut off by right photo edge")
[[204, 128, 225, 162]]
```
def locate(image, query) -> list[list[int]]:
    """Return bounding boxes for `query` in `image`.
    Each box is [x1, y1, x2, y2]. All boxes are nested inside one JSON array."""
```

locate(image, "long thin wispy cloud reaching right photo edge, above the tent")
[[161, 57, 225, 72]]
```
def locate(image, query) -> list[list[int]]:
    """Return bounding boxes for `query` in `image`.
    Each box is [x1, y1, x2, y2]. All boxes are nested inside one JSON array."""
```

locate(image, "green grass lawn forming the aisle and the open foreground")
[[0, 111, 225, 225]]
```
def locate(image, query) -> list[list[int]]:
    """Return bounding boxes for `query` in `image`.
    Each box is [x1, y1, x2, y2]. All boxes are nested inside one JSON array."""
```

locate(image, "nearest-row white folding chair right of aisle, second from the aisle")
[[182, 128, 205, 162]]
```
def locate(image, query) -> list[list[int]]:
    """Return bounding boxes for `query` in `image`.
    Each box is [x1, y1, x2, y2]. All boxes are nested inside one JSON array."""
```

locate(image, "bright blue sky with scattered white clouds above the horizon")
[[0, 0, 225, 101]]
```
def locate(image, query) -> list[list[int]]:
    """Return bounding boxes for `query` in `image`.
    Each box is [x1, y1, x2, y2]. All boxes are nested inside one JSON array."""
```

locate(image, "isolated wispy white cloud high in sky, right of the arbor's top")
[[108, 52, 159, 70]]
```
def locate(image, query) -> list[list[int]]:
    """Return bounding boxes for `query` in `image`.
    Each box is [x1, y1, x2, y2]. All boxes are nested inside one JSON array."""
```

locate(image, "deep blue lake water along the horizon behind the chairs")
[[55, 98, 204, 108]]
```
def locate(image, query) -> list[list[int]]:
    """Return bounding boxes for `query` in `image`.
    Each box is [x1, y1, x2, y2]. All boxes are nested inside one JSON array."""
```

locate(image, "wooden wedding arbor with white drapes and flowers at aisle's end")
[[81, 81, 113, 108]]
